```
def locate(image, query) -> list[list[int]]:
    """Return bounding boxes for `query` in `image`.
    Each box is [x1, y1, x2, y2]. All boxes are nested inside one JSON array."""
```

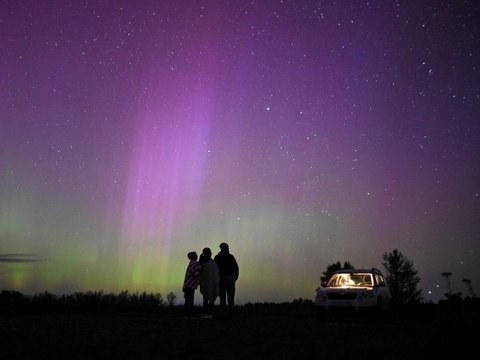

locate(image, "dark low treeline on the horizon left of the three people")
[[0, 290, 169, 313]]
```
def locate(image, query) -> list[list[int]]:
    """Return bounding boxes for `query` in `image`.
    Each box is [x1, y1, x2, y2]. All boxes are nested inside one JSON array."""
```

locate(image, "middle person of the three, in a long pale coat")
[[200, 248, 220, 318]]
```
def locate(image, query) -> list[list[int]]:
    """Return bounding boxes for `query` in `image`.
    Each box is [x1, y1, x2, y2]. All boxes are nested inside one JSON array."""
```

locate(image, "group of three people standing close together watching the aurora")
[[182, 243, 239, 318]]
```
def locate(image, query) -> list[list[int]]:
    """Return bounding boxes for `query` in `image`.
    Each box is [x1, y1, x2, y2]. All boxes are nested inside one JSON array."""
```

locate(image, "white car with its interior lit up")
[[315, 268, 391, 321]]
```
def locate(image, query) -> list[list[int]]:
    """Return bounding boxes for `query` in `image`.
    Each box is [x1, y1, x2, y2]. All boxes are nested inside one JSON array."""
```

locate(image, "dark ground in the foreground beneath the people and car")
[[0, 308, 480, 359]]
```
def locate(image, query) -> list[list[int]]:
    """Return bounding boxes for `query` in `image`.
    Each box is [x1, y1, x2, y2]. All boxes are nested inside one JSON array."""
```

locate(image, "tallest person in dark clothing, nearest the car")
[[214, 243, 239, 313]]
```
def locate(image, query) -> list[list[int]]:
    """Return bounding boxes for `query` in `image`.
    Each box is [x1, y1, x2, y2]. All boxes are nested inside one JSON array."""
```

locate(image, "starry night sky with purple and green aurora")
[[0, 0, 480, 303]]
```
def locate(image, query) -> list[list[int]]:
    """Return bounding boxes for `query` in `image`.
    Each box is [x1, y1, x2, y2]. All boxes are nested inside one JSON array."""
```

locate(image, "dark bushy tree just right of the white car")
[[382, 249, 422, 306]]
